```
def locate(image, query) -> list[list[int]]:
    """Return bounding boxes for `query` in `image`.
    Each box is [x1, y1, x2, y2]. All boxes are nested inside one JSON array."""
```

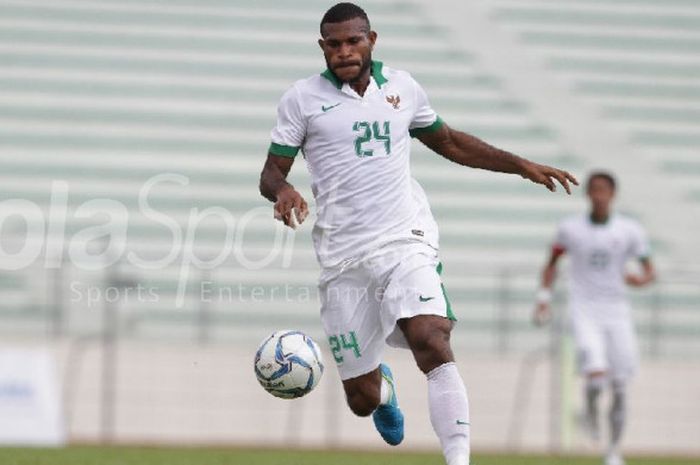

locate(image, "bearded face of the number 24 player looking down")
[[318, 18, 377, 83]]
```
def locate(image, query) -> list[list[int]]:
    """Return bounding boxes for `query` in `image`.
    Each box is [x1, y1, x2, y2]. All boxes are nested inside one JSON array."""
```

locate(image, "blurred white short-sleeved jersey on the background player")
[[555, 214, 650, 312]]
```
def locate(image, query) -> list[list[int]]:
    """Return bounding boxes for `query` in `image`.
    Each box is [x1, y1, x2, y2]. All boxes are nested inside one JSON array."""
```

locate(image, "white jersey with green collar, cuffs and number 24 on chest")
[[270, 61, 442, 267]]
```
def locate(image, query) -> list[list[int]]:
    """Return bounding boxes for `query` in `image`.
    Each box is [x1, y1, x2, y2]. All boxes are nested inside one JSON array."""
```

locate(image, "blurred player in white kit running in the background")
[[535, 171, 654, 465]]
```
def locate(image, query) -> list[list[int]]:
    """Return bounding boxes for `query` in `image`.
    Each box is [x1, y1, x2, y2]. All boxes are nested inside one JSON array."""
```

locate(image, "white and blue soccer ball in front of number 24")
[[255, 329, 323, 399]]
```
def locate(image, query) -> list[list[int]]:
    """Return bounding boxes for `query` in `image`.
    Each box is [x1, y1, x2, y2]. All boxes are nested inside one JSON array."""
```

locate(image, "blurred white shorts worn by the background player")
[[571, 309, 639, 381]]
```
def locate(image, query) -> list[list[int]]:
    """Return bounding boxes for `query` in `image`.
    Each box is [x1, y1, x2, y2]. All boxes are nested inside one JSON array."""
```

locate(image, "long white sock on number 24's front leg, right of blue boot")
[[428, 363, 470, 465]]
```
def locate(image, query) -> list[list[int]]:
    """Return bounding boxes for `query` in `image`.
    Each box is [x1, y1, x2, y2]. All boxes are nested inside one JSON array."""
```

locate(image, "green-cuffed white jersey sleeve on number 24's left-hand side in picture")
[[269, 87, 306, 158]]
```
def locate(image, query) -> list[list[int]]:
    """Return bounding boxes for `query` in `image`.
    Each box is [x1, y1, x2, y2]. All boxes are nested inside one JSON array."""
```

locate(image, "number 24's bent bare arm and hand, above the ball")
[[260, 153, 309, 228]]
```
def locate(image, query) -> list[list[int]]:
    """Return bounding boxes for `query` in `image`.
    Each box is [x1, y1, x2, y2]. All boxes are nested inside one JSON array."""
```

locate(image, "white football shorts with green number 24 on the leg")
[[319, 241, 455, 380]]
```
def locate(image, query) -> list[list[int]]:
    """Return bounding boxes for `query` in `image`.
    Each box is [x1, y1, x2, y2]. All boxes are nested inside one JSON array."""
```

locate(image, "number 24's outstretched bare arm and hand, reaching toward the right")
[[417, 123, 578, 194]]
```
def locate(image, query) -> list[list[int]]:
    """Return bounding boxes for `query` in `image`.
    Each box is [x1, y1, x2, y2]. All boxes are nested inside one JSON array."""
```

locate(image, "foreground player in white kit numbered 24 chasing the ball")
[[260, 3, 577, 465]]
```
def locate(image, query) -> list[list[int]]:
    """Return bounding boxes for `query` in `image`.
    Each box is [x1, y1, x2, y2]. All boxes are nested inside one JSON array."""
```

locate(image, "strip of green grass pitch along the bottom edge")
[[0, 446, 700, 465]]
